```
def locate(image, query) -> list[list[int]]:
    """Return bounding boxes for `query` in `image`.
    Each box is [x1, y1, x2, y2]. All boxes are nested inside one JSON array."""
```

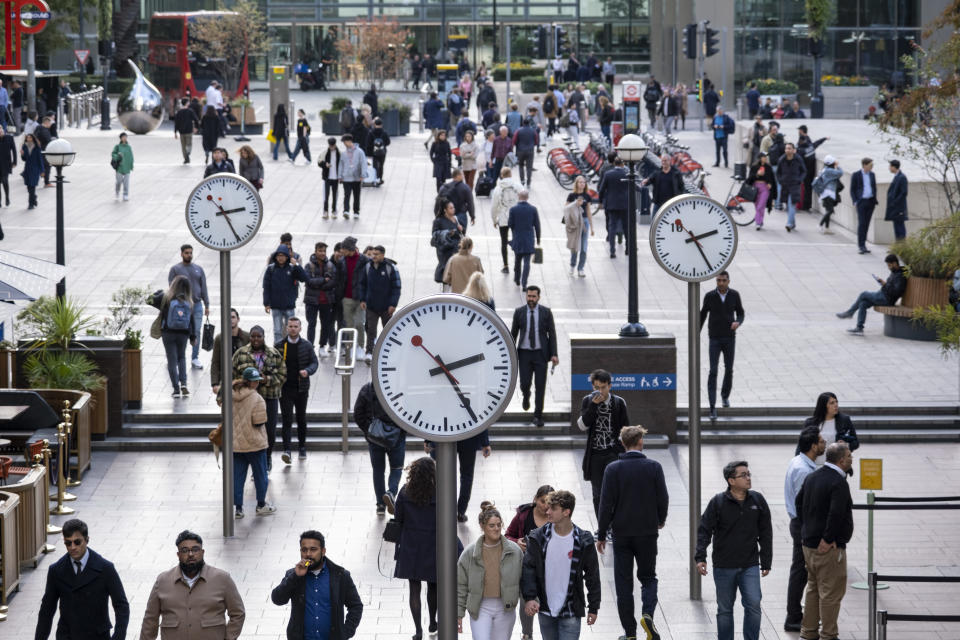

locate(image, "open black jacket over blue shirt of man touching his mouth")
[[270, 558, 363, 640]]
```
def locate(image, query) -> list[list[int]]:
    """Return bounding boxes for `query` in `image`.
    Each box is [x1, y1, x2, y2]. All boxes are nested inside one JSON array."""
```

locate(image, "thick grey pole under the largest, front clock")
[[436, 442, 457, 640]]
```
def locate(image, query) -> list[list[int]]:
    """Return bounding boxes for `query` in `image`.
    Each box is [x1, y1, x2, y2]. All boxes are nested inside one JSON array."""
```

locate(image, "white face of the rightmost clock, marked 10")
[[650, 195, 737, 282]]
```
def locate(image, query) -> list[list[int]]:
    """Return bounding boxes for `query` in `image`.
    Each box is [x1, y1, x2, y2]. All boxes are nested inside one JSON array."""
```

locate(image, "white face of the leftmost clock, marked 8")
[[187, 173, 263, 251]]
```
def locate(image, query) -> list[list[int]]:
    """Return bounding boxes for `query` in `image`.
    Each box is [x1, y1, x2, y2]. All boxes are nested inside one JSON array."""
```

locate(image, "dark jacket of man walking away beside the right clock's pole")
[[590, 450, 670, 540]]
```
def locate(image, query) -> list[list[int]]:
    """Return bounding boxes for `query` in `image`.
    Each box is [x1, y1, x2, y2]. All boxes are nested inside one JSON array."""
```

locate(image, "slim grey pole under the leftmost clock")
[[220, 251, 234, 538]]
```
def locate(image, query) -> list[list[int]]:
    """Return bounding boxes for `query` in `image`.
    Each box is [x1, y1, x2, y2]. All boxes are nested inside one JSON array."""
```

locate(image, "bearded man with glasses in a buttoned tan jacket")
[[140, 531, 246, 640]]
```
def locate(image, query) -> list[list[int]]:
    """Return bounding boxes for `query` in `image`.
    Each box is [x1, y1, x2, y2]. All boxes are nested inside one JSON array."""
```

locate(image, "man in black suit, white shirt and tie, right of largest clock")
[[510, 285, 560, 427]]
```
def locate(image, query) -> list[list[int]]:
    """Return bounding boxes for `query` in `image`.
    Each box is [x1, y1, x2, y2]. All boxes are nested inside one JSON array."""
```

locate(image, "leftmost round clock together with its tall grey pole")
[[186, 173, 269, 538]]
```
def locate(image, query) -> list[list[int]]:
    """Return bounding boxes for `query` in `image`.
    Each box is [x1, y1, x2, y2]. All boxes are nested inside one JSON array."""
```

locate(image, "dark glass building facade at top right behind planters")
[[734, 0, 924, 92]]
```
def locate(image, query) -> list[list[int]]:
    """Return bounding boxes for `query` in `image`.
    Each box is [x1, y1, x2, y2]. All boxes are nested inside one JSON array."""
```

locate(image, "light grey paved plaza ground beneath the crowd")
[[0, 87, 960, 640]]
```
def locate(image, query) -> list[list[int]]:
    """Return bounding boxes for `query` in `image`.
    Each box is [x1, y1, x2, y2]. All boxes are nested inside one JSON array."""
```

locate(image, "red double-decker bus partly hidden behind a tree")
[[147, 11, 249, 105]]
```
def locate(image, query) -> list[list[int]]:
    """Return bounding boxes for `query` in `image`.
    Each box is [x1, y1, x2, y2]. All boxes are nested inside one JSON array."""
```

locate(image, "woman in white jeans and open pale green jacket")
[[457, 502, 523, 640]]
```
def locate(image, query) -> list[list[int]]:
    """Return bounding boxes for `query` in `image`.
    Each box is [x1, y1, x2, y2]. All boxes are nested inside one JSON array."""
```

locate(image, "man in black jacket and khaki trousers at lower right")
[[794, 441, 853, 638]]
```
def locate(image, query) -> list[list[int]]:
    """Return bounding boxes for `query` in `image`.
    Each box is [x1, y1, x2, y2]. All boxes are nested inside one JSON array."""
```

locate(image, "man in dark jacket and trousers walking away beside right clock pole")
[[597, 426, 670, 638]]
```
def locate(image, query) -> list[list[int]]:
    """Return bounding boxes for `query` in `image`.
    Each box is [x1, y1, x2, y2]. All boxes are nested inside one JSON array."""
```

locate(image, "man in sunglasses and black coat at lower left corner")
[[33, 520, 130, 640]]
